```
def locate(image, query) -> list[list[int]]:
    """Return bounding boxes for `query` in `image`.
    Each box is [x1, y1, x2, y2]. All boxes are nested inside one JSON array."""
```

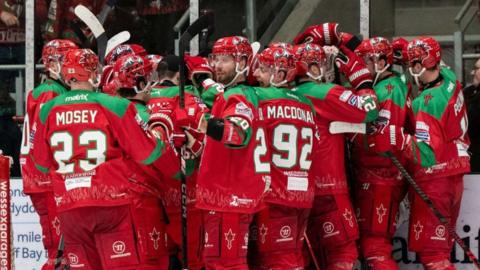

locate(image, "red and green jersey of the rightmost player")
[[405, 68, 470, 180]]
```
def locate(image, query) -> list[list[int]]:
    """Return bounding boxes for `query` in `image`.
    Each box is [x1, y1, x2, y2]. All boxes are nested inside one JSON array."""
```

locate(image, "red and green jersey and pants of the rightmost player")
[[404, 68, 470, 269]]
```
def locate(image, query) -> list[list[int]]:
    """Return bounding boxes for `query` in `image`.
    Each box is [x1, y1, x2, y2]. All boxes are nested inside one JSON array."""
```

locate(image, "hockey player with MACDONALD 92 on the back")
[[252, 46, 318, 269]]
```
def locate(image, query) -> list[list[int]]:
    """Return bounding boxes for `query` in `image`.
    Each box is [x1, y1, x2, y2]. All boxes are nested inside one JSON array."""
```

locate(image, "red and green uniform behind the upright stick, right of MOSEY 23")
[[148, 86, 208, 270]]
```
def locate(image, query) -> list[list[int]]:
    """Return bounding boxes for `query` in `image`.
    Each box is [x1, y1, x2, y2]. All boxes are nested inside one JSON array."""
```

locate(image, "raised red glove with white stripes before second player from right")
[[335, 45, 373, 90]]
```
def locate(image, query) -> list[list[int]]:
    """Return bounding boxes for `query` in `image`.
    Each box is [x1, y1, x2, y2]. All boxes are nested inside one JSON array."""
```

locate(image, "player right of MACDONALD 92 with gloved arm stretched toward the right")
[[295, 43, 378, 270]]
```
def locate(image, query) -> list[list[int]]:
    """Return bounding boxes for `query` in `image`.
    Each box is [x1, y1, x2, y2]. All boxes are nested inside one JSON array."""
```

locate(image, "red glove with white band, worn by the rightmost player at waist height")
[[367, 125, 409, 154]]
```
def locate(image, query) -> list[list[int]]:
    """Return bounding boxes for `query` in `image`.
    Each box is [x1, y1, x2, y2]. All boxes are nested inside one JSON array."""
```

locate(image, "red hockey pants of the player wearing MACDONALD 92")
[[249, 204, 310, 270]]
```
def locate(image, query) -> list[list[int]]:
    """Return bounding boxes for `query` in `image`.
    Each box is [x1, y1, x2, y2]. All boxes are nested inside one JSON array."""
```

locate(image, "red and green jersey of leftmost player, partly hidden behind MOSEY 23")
[[20, 79, 67, 194]]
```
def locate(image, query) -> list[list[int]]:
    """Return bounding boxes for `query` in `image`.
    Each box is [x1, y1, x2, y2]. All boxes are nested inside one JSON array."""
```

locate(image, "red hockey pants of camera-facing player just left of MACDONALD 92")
[[203, 210, 253, 270]]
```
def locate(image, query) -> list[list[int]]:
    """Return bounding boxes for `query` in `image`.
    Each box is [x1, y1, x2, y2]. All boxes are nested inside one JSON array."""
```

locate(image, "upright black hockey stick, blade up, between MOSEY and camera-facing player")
[[179, 12, 213, 269]]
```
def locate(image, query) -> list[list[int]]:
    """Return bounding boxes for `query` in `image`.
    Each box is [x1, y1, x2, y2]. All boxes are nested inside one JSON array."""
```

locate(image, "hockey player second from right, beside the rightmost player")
[[352, 37, 412, 270]]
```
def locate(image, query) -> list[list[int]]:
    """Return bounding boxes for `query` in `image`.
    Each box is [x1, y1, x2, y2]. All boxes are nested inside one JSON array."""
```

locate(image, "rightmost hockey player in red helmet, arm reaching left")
[[369, 37, 470, 270]]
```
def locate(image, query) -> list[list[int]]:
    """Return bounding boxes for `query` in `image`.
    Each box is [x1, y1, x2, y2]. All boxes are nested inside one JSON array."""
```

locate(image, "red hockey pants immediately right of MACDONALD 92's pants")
[[307, 194, 359, 269]]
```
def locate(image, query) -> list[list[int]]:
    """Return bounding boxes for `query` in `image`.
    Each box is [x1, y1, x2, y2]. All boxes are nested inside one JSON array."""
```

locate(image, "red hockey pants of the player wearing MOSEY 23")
[[59, 197, 169, 270]]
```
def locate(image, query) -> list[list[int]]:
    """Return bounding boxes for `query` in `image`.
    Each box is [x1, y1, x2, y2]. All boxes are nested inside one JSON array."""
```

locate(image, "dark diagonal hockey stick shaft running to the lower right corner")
[[386, 152, 480, 270]]
